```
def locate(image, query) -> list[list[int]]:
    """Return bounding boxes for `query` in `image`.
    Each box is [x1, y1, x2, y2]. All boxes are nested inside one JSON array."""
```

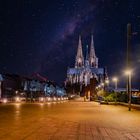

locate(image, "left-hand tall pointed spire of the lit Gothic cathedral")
[[75, 36, 84, 67]]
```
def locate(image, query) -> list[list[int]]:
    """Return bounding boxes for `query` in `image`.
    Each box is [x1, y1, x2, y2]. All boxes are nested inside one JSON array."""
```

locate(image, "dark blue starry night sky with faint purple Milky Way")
[[0, 0, 140, 87]]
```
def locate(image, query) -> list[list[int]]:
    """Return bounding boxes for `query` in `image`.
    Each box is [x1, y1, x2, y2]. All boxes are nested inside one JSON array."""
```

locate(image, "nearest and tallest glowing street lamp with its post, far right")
[[125, 70, 132, 111]]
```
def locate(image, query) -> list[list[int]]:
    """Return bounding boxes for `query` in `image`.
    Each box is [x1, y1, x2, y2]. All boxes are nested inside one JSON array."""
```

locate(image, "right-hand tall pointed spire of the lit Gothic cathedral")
[[89, 35, 98, 67]]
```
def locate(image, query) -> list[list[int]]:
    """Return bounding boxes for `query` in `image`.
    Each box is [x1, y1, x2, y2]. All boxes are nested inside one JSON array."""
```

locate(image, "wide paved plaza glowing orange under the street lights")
[[0, 102, 140, 140]]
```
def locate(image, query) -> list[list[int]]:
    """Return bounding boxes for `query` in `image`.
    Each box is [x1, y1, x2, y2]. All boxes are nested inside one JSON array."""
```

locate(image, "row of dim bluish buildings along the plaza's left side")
[[0, 74, 66, 101]]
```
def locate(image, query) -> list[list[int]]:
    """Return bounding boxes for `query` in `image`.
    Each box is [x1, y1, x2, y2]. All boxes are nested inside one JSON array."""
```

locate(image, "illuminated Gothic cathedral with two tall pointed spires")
[[66, 35, 107, 95]]
